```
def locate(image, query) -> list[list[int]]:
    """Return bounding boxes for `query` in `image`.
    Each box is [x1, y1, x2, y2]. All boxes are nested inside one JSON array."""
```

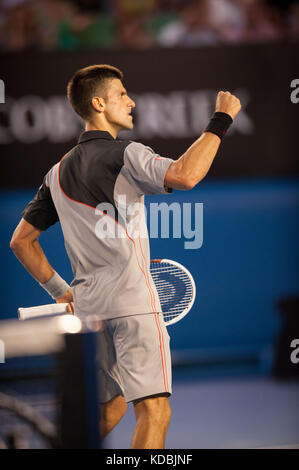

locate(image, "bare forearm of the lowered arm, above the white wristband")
[[12, 240, 54, 283]]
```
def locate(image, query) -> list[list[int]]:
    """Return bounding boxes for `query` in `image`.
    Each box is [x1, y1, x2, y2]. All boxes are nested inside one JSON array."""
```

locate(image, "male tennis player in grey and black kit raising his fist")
[[10, 65, 241, 449]]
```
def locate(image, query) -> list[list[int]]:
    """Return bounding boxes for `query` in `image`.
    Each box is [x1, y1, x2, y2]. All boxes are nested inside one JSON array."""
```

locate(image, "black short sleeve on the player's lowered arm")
[[22, 173, 59, 231]]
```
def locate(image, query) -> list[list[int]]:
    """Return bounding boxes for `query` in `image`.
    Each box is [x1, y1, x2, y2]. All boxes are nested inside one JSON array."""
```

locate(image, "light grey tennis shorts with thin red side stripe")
[[99, 313, 172, 403]]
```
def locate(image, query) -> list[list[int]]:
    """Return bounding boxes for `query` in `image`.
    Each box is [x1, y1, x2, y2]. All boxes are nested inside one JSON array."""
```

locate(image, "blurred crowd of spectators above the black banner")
[[0, 0, 299, 51]]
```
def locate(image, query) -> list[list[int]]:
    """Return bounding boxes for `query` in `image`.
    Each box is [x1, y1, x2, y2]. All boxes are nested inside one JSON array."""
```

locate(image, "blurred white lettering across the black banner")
[[0, 89, 255, 144]]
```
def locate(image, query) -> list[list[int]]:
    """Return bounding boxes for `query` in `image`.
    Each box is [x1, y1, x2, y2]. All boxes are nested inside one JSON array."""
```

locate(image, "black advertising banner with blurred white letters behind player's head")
[[0, 44, 299, 187]]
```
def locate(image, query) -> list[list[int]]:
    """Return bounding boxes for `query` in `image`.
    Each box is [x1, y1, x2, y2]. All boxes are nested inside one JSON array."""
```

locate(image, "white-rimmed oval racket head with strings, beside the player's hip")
[[150, 258, 196, 326]]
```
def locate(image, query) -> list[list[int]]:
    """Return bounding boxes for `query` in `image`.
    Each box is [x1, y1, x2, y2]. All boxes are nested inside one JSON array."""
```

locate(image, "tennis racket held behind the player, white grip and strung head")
[[18, 259, 196, 326]]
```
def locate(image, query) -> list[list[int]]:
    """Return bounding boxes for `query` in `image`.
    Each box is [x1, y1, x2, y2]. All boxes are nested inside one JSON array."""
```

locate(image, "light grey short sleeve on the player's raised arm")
[[124, 142, 174, 195]]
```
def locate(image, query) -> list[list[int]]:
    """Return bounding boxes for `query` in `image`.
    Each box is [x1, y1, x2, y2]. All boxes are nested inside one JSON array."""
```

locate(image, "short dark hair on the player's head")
[[67, 64, 123, 120]]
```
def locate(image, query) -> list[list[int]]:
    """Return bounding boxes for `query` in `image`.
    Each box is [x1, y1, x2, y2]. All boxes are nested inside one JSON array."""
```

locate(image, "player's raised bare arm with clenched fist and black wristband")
[[164, 91, 241, 190]]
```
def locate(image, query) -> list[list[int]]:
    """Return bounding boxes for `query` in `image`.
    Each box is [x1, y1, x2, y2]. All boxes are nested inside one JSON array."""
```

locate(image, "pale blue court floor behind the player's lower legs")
[[103, 377, 299, 449]]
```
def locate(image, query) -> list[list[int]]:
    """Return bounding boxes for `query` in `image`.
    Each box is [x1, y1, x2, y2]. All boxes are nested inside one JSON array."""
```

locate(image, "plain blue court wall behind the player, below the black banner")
[[0, 180, 299, 370]]
